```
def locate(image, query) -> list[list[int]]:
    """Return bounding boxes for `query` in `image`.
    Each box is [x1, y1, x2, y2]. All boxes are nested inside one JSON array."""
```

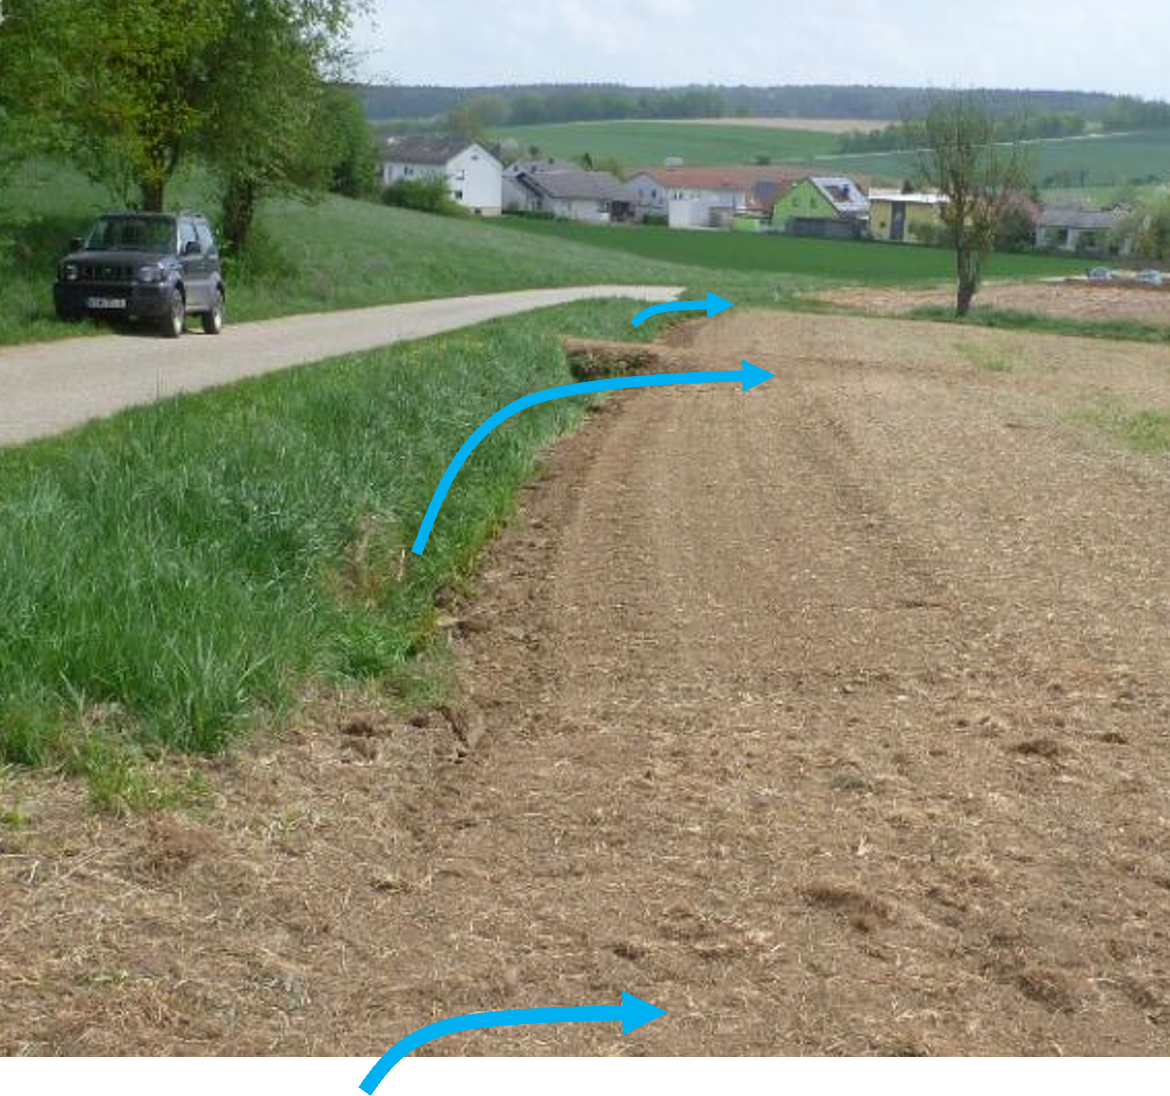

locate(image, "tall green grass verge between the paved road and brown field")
[[0, 302, 654, 802]]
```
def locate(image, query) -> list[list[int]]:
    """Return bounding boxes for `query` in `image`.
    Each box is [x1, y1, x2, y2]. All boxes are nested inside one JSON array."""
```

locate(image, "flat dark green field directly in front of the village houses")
[[504, 218, 1085, 285]]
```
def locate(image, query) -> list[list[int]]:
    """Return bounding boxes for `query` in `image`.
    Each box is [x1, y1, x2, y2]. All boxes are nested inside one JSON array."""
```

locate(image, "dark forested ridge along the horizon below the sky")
[[359, 84, 1135, 125]]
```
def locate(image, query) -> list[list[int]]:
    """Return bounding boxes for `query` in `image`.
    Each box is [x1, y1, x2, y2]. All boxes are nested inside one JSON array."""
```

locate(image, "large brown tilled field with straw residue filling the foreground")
[[0, 312, 1170, 1057]]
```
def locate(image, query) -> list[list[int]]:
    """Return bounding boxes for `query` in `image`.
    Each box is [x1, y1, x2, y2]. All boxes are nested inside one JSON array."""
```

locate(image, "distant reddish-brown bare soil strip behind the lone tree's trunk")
[[812, 282, 1170, 326]]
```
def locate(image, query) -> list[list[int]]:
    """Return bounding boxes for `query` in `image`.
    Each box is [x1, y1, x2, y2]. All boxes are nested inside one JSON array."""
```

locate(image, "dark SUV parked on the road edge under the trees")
[[53, 213, 227, 338]]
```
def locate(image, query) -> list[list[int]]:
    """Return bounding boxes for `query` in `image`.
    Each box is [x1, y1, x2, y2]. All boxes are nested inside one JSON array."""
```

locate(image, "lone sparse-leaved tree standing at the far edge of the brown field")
[[920, 92, 1030, 316]]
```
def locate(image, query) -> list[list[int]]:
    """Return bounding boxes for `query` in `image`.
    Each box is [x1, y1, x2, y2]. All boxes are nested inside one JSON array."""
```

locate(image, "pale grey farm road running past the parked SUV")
[[0, 285, 681, 447]]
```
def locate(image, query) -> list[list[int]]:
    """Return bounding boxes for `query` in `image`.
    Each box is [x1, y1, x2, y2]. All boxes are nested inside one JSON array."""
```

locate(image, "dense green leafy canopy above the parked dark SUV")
[[0, 0, 367, 232]]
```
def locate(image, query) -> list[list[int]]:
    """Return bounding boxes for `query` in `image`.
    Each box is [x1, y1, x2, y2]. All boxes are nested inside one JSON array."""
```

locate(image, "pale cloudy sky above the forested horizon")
[[355, 0, 1170, 98]]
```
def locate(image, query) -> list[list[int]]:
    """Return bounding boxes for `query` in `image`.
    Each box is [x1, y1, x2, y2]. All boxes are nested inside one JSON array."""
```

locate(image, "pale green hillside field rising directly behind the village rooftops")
[[491, 122, 838, 167]]
